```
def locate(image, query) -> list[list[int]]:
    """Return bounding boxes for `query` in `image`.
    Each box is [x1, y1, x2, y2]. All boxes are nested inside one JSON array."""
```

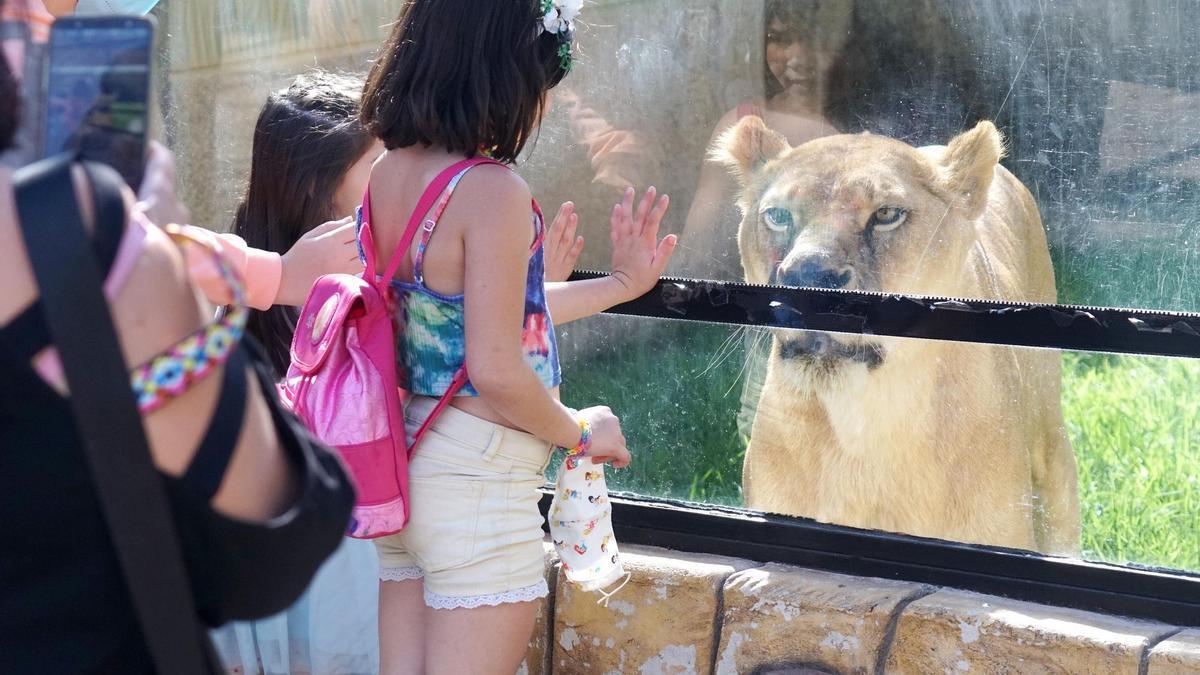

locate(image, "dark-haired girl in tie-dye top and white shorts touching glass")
[[355, 0, 676, 674]]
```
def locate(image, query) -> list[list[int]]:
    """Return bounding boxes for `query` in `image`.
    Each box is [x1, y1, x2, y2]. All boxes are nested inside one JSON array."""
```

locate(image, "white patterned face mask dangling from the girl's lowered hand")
[[550, 458, 629, 603]]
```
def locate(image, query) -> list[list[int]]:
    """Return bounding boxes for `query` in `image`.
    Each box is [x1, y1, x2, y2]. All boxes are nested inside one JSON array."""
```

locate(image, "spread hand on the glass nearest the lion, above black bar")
[[611, 187, 679, 300]]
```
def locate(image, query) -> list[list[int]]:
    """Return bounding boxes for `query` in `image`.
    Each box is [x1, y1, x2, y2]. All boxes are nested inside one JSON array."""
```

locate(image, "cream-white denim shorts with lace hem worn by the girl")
[[374, 396, 551, 609]]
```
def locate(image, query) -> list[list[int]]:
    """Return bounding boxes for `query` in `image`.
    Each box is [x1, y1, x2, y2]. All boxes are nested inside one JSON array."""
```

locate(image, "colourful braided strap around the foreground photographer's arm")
[[131, 225, 250, 414]]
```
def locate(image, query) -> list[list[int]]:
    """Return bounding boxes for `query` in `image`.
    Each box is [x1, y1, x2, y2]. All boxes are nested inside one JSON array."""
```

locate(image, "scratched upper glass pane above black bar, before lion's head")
[[526, 0, 1200, 310]]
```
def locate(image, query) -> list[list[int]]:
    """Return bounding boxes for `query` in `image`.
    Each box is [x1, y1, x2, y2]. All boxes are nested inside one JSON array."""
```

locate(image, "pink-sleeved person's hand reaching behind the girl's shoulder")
[[275, 216, 362, 306]]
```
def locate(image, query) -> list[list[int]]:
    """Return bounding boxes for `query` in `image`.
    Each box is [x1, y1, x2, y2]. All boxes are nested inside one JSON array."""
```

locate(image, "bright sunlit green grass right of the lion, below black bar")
[[1062, 354, 1200, 571]]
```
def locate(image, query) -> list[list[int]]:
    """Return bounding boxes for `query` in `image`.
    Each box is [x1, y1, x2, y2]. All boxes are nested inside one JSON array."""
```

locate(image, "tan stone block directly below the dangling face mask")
[[553, 546, 752, 675]]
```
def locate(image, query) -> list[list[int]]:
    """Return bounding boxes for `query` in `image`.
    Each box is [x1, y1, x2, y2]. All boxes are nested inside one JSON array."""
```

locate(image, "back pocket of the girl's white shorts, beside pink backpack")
[[404, 478, 484, 573]]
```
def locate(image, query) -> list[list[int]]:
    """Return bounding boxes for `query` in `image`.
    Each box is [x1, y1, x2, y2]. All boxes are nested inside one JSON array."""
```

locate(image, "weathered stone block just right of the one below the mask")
[[716, 563, 928, 675]]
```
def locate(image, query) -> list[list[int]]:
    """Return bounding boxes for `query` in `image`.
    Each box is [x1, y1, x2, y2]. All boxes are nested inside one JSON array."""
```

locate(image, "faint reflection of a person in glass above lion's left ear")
[[679, 0, 852, 279]]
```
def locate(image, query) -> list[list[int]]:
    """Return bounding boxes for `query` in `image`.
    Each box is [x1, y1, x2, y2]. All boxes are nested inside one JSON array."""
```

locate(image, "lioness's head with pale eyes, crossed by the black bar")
[[713, 117, 1002, 372]]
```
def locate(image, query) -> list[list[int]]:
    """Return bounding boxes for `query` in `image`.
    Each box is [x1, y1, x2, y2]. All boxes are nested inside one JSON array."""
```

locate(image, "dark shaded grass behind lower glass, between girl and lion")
[[563, 316, 745, 506]]
